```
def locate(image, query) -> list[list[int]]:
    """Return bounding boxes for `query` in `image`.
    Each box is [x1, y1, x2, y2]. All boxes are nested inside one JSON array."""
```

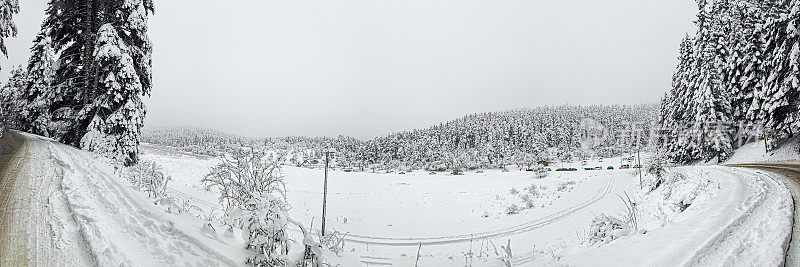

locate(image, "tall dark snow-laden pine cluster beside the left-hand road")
[[34, 0, 153, 164]]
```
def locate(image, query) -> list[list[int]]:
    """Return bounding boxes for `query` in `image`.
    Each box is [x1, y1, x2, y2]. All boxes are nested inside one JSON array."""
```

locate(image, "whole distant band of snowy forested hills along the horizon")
[[142, 104, 658, 169]]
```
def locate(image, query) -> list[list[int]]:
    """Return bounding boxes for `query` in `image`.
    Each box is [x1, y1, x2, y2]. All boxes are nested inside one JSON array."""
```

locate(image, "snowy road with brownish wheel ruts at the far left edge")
[[0, 131, 93, 266]]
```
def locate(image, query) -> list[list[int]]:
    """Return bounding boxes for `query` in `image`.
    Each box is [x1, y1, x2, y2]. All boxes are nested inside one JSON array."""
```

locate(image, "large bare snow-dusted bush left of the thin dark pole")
[[202, 148, 289, 266]]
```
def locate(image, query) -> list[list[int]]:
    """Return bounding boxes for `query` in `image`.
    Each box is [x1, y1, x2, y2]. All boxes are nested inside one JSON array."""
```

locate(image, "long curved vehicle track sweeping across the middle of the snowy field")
[[345, 178, 614, 246]]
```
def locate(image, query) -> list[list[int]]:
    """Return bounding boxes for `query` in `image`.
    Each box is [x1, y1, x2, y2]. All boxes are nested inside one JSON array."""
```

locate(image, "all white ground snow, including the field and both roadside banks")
[[6, 135, 793, 266]]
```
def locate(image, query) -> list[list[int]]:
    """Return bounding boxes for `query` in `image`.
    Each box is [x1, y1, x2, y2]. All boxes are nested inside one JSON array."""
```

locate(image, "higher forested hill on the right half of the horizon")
[[356, 105, 658, 169]]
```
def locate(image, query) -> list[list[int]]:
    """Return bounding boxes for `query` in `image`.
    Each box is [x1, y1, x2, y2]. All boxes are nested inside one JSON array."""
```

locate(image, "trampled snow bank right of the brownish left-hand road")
[[29, 136, 246, 266]]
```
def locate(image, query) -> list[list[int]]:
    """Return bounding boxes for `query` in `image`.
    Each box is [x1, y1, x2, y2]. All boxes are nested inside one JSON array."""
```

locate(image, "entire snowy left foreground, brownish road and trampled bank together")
[[0, 131, 243, 266]]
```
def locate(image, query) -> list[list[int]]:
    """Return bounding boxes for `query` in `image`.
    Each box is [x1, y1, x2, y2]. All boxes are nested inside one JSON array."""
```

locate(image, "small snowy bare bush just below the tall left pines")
[[123, 161, 172, 198]]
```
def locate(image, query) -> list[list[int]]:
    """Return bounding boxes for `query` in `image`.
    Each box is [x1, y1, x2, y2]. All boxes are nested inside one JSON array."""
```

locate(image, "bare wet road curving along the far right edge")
[[726, 162, 800, 266]]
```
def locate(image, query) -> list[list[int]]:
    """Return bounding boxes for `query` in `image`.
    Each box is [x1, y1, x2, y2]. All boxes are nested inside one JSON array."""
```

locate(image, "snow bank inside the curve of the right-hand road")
[[558, 167, 793, 266]]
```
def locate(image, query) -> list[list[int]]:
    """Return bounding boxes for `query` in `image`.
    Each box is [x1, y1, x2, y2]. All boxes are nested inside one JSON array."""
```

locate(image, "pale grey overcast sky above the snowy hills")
[[2, 0, 696, 138]]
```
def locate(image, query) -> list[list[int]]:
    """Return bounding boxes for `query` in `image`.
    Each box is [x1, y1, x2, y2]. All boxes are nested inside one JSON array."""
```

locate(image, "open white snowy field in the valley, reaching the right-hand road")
[[142, 142, 792, 266]]
